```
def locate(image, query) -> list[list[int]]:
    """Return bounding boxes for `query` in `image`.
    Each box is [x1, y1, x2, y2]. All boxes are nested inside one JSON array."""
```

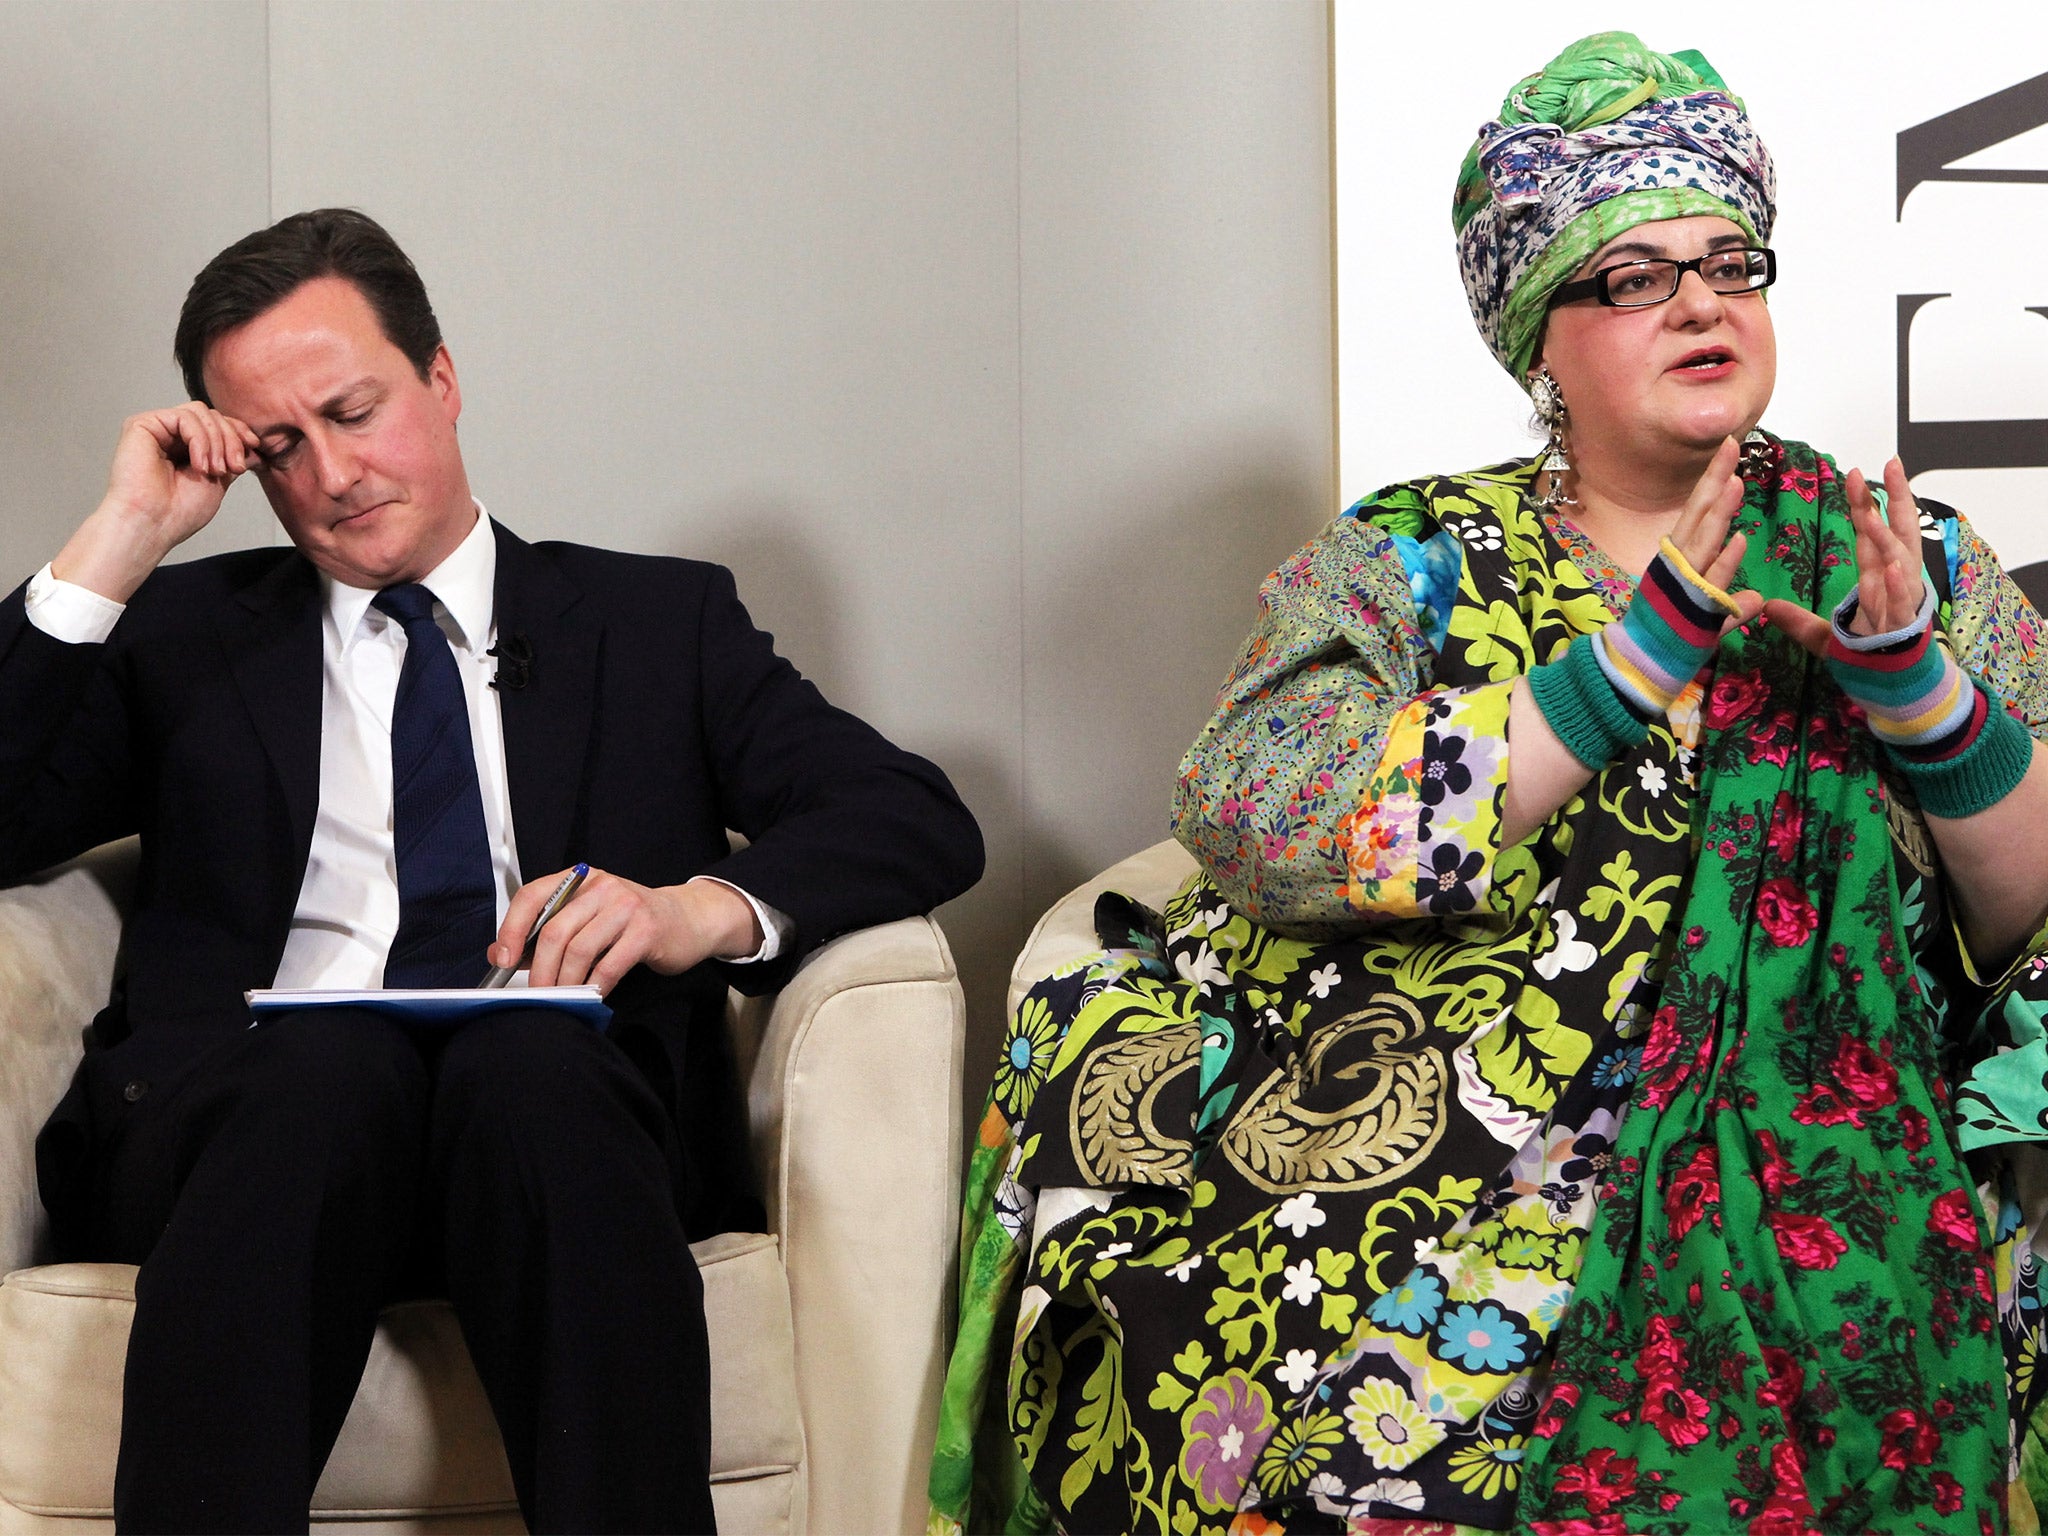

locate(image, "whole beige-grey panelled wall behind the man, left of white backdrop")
[[0, 0, 1335, 1146]]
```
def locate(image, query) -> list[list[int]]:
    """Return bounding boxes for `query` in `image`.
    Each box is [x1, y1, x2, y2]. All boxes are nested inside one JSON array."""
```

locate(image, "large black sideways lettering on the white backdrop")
[[1894, 74, 2048, 608]]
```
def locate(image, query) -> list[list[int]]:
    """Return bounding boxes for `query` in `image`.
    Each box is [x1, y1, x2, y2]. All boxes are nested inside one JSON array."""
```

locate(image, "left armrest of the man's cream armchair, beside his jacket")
[[0, 840, 135, 1274]]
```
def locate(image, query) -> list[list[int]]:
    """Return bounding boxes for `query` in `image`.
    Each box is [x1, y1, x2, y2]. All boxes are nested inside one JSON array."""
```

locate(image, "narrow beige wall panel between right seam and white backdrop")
[[1020, 0, 1333, 911]]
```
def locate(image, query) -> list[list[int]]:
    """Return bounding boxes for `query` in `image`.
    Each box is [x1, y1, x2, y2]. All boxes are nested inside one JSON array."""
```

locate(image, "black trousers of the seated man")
[[83, 1010, 713, 1532]]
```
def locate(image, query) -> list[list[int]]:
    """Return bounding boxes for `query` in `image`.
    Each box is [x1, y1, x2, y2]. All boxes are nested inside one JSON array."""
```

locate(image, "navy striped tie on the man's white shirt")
[[371, 584, 498, 987]]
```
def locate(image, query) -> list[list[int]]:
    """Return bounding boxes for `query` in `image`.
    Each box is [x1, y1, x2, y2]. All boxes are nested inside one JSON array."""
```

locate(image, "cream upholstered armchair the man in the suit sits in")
[[0, 844, 963, 1536]]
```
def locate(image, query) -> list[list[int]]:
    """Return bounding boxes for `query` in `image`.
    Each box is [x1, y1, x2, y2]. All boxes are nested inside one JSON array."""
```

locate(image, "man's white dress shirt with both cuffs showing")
[[25, 504, 788, 987]]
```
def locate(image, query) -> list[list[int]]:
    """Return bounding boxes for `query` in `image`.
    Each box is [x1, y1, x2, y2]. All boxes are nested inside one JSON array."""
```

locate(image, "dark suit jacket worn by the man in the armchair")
[[0, 526, 981, 1247]]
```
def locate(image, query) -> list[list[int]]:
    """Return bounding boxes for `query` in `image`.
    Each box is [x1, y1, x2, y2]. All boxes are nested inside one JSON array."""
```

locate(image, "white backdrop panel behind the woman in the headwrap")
[[1333, 0, 2048, 567]]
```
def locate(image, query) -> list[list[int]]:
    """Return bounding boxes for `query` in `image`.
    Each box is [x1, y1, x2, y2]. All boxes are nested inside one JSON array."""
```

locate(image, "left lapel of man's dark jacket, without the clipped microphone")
[[215, 553, 322, 897]]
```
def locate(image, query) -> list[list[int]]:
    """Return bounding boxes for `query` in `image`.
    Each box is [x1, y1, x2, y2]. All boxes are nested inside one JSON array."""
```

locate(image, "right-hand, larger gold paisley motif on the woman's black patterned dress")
[[1221, 995, 1448, 1194]]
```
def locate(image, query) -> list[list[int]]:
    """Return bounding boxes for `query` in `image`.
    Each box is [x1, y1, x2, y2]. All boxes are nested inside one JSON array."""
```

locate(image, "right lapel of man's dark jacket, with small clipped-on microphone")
[[492, 522, 604, 881]]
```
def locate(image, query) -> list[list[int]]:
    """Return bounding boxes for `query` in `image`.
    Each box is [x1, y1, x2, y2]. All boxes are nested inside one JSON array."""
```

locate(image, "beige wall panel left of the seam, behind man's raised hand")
[[0, 0, 274, 592]]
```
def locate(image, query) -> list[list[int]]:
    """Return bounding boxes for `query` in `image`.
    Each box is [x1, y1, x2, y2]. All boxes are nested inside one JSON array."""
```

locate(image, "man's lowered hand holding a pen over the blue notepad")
[[489, 870, 762, 993]]
